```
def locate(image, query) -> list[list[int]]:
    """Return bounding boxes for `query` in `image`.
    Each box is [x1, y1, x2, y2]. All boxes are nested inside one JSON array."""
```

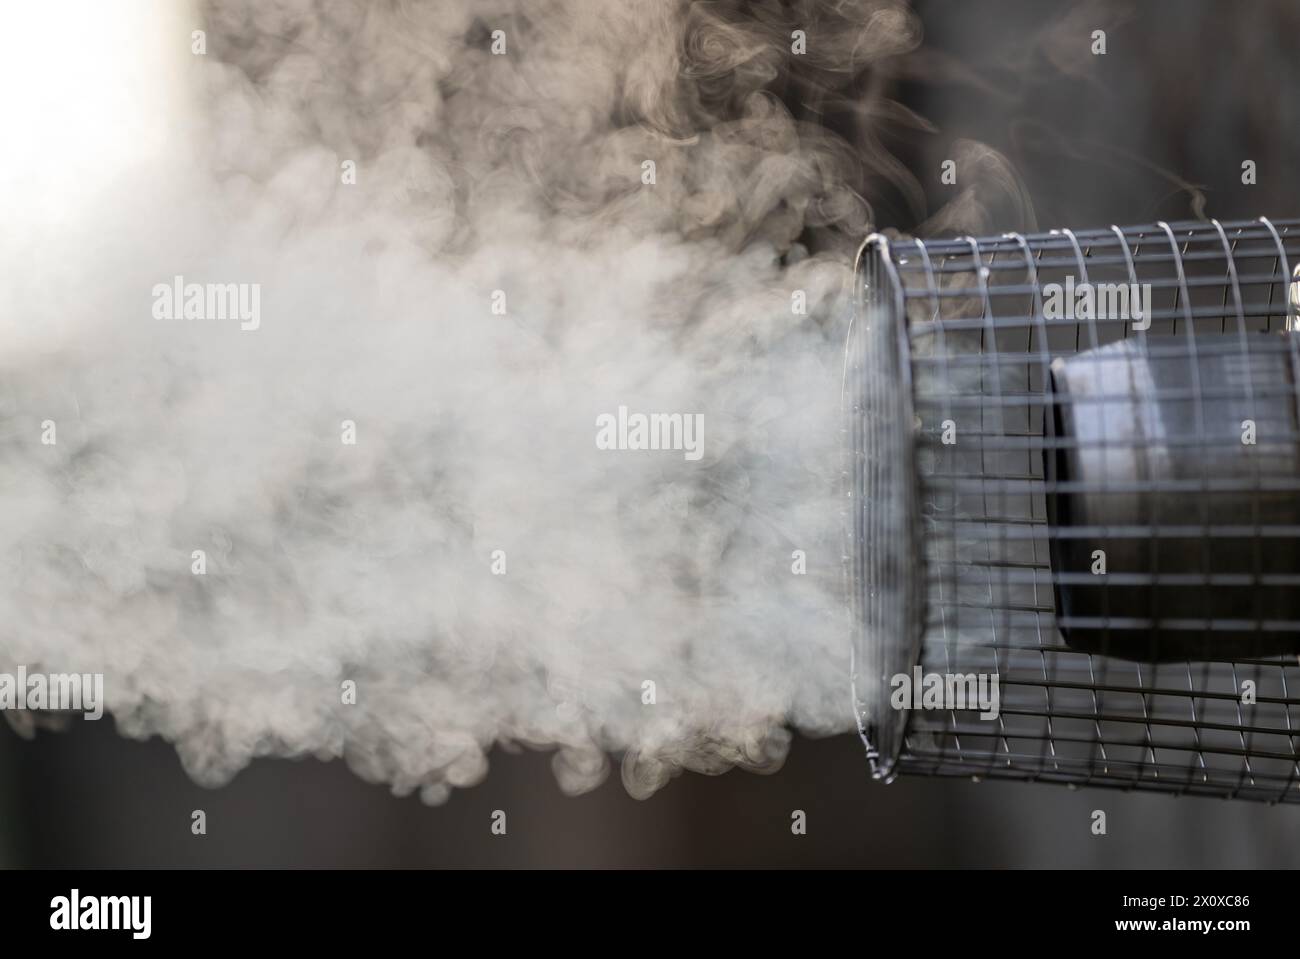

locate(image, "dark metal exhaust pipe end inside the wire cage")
[[1044, 334, 1300, 661]]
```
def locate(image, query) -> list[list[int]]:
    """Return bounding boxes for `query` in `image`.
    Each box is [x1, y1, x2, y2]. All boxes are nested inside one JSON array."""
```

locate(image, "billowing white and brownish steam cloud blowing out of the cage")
[[0, 0, 1024, 802]]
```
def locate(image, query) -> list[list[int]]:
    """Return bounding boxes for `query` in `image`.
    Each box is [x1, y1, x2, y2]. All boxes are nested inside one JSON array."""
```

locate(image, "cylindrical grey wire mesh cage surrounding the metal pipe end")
[[845, 218, 1300, 802]]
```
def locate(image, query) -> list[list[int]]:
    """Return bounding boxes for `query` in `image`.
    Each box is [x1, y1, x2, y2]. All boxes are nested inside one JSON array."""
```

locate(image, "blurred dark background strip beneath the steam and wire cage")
[[0, 721, 1300, 868]]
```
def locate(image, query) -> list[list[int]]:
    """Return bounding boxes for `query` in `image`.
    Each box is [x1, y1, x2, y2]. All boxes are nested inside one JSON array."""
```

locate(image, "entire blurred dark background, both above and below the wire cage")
[[0, 0, 1300, 867]]
